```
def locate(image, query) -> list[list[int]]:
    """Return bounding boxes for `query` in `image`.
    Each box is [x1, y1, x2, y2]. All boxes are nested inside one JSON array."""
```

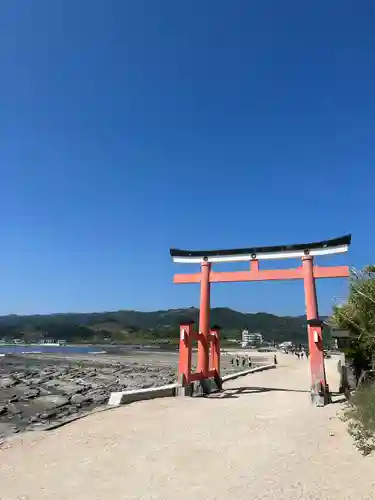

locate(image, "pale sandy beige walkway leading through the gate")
[[0, 360, 375, 500]]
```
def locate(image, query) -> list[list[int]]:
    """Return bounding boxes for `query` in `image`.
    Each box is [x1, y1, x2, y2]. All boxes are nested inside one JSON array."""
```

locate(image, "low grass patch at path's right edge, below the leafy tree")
[[344, 383, 375, 455]]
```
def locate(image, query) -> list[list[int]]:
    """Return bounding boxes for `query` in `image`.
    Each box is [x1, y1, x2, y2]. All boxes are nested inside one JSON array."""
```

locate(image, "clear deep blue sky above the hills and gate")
[[0, 0, 375, 314]]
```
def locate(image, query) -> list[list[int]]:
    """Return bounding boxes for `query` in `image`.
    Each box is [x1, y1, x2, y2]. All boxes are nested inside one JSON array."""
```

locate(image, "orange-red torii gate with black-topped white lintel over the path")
[[170, 235, 351, 406]]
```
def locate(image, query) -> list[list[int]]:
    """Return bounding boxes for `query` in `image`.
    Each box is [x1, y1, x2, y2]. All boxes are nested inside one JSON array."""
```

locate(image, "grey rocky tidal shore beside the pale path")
[[0, 350, 270, 444]]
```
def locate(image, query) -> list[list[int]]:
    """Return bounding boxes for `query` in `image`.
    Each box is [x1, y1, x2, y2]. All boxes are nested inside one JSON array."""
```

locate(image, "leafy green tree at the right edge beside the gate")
[[332, 265, 375, 376]]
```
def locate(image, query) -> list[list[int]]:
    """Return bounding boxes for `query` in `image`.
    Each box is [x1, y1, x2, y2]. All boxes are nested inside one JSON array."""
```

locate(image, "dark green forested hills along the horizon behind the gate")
[[0, 307, 328, 343]]
